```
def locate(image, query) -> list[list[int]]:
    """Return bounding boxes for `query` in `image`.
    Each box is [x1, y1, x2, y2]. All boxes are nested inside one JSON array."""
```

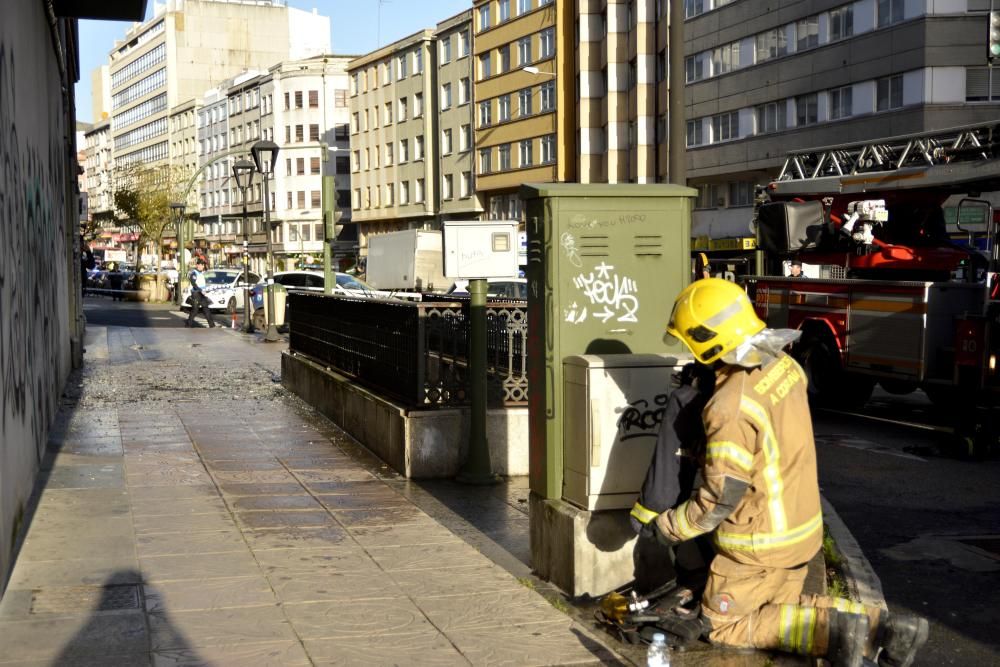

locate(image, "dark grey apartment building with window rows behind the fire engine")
[[684, 0, 1000, 246]]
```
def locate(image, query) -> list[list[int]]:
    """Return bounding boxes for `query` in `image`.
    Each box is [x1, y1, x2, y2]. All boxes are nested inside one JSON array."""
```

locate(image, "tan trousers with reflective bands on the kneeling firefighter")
[[701, 554, 880, 656]]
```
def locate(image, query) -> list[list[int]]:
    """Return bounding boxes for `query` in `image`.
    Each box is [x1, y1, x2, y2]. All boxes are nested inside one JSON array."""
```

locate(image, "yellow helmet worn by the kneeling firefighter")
[[667, 278, 764, 364]]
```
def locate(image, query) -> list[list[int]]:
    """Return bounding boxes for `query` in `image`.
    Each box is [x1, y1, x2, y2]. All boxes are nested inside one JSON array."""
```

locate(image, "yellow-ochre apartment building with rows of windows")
[[472, 0, 576, 219]]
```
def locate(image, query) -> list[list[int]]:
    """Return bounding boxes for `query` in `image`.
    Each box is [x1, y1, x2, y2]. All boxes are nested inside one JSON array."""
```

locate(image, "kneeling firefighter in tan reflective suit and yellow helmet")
[[644, 278, 928, 667]]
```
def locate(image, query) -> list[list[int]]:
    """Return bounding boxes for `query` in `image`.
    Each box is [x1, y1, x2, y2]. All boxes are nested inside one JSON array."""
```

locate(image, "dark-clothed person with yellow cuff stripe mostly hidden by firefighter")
[[630, 362, 715, 595]]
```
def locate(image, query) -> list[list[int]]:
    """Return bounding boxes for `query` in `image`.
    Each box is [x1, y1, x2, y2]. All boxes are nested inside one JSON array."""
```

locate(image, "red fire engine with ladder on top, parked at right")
[[746, 122, 1000, 456]]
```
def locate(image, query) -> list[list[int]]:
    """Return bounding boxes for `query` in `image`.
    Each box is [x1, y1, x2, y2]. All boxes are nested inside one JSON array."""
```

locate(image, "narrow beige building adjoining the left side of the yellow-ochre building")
[[434, 9, 484, 220]]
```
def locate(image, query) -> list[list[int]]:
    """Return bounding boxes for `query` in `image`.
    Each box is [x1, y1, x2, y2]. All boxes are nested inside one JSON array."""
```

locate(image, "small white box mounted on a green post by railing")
[[444, 220, 520, 279]]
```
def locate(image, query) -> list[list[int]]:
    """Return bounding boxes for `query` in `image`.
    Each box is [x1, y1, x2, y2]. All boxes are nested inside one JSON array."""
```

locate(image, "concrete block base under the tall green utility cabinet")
[[529, 493, 636, 597]]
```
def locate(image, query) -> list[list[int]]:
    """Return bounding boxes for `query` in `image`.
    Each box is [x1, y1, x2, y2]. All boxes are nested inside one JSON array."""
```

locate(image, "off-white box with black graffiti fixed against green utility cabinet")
[[563, 354, 692, 510]]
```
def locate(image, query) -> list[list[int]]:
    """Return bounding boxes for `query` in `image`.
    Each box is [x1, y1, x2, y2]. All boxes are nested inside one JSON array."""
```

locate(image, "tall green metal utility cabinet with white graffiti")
[[521, 183, 697, 499]]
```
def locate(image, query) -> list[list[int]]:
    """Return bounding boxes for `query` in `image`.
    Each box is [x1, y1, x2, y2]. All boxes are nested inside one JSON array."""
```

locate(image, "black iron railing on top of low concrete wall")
[[288, 293, 528, 408]]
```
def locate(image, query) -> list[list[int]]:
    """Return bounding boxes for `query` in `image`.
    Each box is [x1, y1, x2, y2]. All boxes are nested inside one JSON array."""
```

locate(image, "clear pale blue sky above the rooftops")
[[76, 0, 472, 122]]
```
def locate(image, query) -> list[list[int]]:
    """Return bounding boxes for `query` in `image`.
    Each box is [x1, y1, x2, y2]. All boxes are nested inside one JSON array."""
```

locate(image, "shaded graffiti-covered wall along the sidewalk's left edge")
[[0, 0, 73, 591]]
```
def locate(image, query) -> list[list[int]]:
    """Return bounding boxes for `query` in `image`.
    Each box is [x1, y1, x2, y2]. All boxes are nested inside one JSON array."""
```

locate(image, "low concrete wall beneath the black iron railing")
[[281, 351, 528, 479]]
